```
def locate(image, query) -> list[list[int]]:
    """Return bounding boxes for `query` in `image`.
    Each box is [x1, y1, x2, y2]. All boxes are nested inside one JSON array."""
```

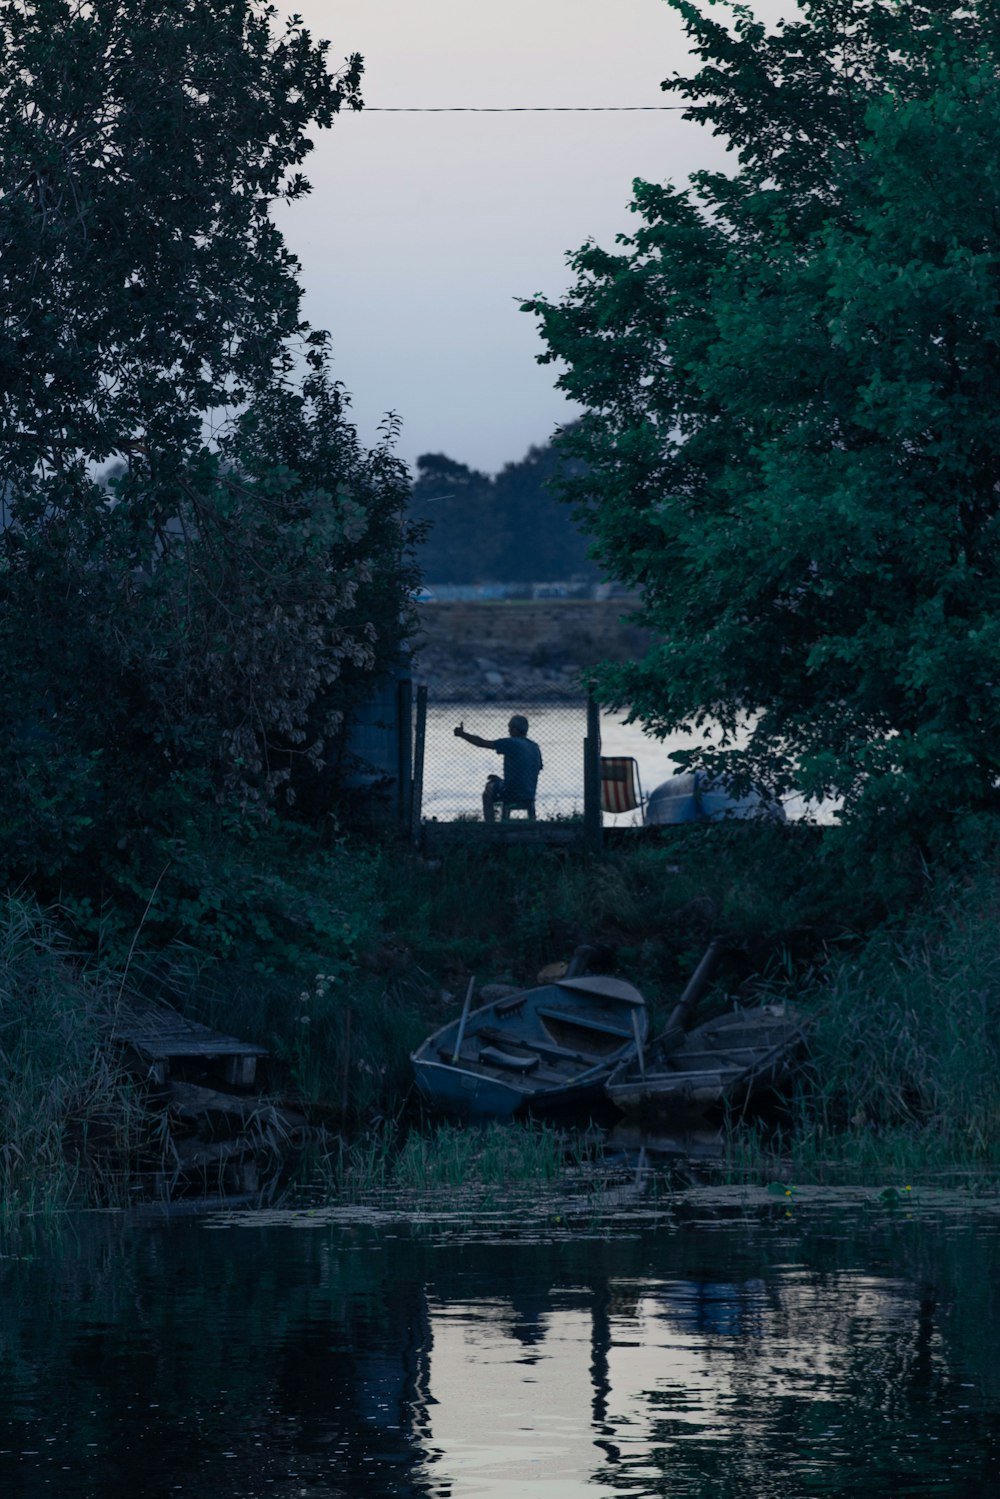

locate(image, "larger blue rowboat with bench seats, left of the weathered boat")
[[411, 974, 649, 1120]]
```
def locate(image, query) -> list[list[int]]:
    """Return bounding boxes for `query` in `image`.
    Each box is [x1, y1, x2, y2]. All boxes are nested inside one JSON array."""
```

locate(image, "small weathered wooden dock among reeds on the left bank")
[[111, 1006, 267, 1088]]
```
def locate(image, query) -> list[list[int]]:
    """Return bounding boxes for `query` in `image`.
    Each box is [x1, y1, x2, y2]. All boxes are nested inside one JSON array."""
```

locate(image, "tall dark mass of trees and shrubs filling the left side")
[[0, 0, 415, 1217]]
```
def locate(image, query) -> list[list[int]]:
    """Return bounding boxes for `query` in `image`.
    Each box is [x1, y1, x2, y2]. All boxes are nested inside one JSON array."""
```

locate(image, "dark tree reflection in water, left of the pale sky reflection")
[[0, 1226, 430, 1499]]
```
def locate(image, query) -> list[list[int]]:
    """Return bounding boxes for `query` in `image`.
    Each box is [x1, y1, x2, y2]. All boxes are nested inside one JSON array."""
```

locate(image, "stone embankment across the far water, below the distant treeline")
[[414, 598, 649, 703]]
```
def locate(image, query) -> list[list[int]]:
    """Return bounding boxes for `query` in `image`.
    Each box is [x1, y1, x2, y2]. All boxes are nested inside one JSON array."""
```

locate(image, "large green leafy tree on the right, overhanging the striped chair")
[[526, 0, 1000, 832]]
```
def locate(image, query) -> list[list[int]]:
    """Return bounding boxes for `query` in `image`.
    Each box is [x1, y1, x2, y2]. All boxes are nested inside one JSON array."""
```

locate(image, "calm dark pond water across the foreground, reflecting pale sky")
[[0, 1189, 1000, 1499]]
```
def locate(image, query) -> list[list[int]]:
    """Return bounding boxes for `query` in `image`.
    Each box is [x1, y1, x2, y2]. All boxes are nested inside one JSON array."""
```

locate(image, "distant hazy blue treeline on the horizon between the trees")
[[411, 442, 598, 585]]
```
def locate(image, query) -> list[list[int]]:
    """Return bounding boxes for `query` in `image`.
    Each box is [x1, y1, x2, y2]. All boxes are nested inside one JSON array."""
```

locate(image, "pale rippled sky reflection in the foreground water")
[[413, 1265, 929, 1499]]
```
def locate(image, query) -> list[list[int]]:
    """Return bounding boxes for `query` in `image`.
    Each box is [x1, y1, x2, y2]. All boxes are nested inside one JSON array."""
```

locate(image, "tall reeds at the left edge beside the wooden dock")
[[0, 896, 145, 1214]]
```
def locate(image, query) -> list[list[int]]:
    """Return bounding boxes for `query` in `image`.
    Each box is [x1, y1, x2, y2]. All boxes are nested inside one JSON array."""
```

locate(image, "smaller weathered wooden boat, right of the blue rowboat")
[[604, 1004, 807, 1115]]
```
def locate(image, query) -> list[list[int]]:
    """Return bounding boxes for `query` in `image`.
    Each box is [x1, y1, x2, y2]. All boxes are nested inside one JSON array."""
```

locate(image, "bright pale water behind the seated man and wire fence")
[[423, 702, 827, 826]]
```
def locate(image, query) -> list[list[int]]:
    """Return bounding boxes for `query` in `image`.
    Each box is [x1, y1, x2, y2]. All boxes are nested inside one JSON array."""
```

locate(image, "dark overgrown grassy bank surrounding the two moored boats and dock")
[[0, 824, 1000, 1210]]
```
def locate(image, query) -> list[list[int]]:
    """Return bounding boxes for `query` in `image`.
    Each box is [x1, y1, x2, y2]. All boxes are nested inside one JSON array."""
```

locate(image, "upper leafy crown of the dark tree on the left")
[[0, 0, 361, 473]]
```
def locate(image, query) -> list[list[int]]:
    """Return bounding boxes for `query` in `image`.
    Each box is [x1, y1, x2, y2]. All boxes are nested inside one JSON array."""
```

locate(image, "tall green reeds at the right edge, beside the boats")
[[710, 866, 1000, 1184]]
